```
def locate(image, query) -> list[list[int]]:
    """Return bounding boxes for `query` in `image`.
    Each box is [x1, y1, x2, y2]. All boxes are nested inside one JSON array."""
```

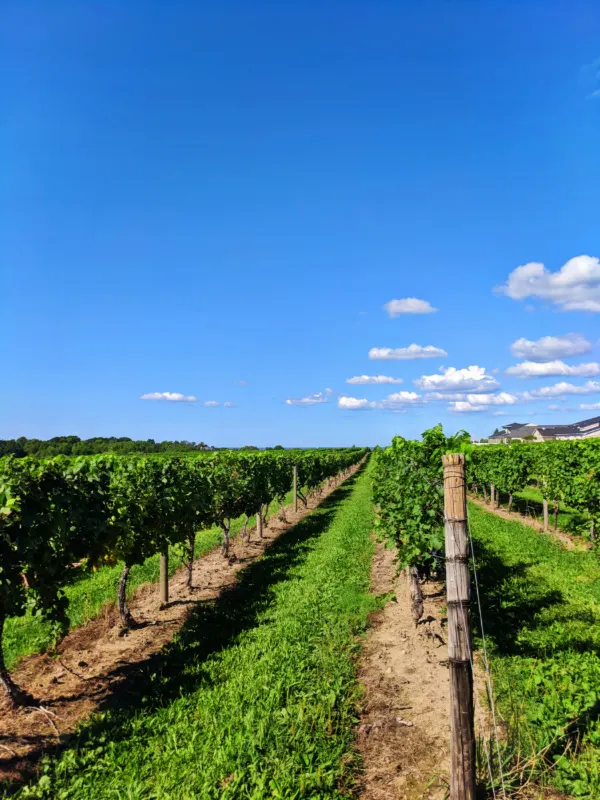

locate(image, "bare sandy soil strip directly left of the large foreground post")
[[358, 543, 450, 800]]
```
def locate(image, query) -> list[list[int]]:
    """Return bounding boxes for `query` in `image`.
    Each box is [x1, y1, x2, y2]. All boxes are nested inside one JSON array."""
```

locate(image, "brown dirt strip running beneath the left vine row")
[[0, 468, 356, 783]]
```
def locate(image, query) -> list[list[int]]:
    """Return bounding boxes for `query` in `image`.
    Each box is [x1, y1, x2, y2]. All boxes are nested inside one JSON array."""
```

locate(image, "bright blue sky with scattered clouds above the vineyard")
[[0, 0, 600, 446]]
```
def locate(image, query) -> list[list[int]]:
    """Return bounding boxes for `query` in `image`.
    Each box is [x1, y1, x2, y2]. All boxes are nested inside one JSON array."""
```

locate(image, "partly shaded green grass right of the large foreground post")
[[469, 504, 600, 798]]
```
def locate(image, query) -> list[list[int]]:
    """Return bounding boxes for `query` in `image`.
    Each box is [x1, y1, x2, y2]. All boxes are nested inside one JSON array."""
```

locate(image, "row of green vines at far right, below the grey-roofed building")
[[468, 439, 600, 539]]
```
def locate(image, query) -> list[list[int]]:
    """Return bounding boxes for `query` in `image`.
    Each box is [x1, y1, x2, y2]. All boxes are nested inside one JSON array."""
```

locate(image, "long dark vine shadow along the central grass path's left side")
[[0, 467, 364, 794]]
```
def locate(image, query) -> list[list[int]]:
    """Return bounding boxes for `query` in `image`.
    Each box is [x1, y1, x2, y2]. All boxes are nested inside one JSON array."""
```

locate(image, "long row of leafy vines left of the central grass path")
[[0, 449, 365, 703]]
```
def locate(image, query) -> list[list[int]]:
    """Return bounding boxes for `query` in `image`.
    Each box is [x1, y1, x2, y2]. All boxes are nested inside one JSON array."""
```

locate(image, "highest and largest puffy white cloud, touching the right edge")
[[497, 255, 600, 312]]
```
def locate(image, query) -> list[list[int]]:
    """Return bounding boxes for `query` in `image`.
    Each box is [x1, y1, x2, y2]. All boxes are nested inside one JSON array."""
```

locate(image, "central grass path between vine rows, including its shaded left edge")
[[8, 473, 376, 800]]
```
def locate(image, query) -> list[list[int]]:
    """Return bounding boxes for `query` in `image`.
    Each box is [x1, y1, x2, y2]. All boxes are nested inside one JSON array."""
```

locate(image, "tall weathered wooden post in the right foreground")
[[442, 453, 476, 800]]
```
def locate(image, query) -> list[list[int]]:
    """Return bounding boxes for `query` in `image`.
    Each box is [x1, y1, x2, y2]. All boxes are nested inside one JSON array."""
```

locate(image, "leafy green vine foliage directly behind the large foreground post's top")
[[373, 425, 471, 568]]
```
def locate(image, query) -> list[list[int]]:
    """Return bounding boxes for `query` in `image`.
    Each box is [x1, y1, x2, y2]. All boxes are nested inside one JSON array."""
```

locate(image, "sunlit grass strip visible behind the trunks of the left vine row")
[[3, 492, 293, 669]]
